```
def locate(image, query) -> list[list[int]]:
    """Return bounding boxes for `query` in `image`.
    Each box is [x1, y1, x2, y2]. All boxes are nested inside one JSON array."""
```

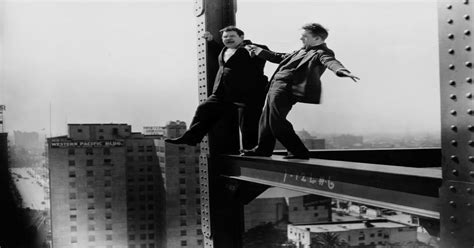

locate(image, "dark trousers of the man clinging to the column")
[[183, 95, 263, 149]]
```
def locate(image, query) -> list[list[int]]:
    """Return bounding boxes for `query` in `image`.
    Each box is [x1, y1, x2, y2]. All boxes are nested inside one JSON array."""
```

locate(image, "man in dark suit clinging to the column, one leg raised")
[[165, 26, 268, 149]]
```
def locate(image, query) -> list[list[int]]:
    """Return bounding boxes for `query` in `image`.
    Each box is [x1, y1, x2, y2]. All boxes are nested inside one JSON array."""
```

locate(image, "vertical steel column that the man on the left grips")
[[194, 0, 243, 248]]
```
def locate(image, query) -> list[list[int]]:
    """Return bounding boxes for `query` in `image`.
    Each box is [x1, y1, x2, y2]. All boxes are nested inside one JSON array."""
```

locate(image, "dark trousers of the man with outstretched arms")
[[256, 82, 309, 156]]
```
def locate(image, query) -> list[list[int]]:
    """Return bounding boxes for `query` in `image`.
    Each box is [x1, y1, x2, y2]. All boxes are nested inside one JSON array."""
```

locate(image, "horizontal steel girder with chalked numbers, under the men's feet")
[[217, 155, 441, 219]]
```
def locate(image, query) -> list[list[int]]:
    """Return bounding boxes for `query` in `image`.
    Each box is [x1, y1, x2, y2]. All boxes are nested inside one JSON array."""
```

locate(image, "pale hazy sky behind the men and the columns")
[[0, 0, 440, 135]]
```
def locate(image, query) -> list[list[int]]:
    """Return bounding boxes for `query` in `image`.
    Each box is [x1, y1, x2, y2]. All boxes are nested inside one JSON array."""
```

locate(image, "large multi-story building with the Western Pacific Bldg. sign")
[[48, 124, 165, 248]]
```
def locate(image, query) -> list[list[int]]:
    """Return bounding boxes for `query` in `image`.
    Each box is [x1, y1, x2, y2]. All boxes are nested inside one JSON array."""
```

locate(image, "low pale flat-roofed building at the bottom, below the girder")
[[288, 219, 418, 248]]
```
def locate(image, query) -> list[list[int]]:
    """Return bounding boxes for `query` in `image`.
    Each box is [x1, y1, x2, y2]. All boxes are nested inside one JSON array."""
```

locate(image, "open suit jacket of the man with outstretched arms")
[[258, 43, 347, 104]]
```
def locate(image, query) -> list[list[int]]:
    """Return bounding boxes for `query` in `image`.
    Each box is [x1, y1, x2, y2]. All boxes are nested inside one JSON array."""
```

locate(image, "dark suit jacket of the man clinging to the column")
[[212, 47, 263, 104]]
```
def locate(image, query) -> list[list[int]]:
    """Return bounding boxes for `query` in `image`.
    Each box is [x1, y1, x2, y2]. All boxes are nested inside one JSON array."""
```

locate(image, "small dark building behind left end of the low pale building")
[[288, 195, 332, 224]]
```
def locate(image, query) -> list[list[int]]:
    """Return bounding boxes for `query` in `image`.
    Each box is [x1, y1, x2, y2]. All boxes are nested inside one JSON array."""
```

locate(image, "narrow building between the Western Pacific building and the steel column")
[[155, 121, 203, 248]]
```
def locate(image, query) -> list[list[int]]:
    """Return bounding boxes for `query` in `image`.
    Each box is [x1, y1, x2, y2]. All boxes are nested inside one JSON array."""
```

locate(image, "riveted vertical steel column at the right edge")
[[438, 0, 474, 248]]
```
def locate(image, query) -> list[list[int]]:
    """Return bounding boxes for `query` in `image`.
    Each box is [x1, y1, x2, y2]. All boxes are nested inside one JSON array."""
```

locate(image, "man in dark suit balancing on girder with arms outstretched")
[[242, 23, 359, 159]]
